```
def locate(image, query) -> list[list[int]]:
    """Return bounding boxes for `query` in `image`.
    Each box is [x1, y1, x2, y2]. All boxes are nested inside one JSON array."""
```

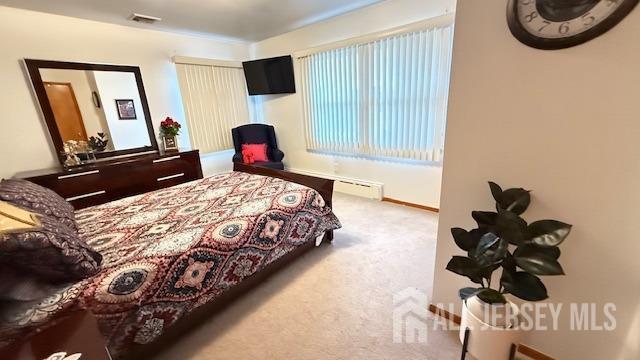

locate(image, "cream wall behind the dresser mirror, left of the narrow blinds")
[[0, 7, 249, 178]]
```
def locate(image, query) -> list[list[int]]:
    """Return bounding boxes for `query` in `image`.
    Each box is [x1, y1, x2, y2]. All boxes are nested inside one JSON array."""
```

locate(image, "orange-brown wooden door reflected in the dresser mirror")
[[44, 82, 88, 142]]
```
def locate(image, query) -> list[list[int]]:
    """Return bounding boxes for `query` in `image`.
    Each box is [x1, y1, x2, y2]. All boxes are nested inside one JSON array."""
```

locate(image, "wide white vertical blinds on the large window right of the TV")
[[300, 23, 453, 161]]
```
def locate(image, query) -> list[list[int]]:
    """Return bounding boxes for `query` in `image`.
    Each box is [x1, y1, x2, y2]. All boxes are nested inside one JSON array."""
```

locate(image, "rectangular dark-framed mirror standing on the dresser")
[[25, 59, 158, 162]]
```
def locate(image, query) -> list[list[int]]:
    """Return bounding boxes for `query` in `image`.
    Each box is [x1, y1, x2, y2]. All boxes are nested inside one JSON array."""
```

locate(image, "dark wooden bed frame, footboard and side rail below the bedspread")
[[123, 163, 333, 360]]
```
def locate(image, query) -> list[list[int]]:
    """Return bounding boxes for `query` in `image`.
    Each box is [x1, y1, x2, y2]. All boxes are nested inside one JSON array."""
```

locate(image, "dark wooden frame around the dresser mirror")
[[24, 59, 158, 164]]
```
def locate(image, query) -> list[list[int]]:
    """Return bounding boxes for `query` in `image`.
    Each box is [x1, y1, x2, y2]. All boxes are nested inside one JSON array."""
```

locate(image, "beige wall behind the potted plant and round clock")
[[433, 0, 640, 360]]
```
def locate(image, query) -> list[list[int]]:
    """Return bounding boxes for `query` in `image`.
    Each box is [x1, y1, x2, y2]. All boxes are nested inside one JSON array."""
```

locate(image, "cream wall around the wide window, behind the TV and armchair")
[[252, 0, 455, 207]]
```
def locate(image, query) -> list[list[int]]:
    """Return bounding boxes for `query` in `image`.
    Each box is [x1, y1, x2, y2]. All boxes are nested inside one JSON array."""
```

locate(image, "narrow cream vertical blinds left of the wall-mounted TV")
[[176, 62, 249, 153]]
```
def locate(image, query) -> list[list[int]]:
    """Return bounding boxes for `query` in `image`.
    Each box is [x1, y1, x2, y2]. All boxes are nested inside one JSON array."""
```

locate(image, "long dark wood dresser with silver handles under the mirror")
[[14, 150, 202, 209]]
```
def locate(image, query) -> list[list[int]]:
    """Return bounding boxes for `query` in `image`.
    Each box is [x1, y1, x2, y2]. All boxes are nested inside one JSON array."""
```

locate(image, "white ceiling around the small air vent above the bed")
[[0, 0, 382, 41]]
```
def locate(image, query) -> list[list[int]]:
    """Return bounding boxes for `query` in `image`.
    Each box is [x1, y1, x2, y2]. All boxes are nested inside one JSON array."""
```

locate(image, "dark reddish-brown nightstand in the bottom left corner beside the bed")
[[0, 311, 111, 360]]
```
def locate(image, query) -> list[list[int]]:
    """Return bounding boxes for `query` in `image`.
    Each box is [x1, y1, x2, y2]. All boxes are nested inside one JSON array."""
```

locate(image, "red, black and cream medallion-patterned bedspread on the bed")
[[4, 172, 340, 356]]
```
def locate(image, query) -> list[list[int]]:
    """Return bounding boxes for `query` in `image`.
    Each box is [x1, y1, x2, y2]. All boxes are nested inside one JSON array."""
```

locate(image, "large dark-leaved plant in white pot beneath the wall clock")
[[447, 182, 571, 360]]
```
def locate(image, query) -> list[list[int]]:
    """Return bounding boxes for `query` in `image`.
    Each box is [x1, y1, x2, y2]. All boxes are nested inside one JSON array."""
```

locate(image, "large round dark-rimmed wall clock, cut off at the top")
[[507, 0, 640, 50]]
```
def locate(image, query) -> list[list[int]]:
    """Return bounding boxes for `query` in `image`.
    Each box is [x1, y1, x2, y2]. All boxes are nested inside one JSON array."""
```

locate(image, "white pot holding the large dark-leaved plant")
[[460, 296, 522, 360]]
